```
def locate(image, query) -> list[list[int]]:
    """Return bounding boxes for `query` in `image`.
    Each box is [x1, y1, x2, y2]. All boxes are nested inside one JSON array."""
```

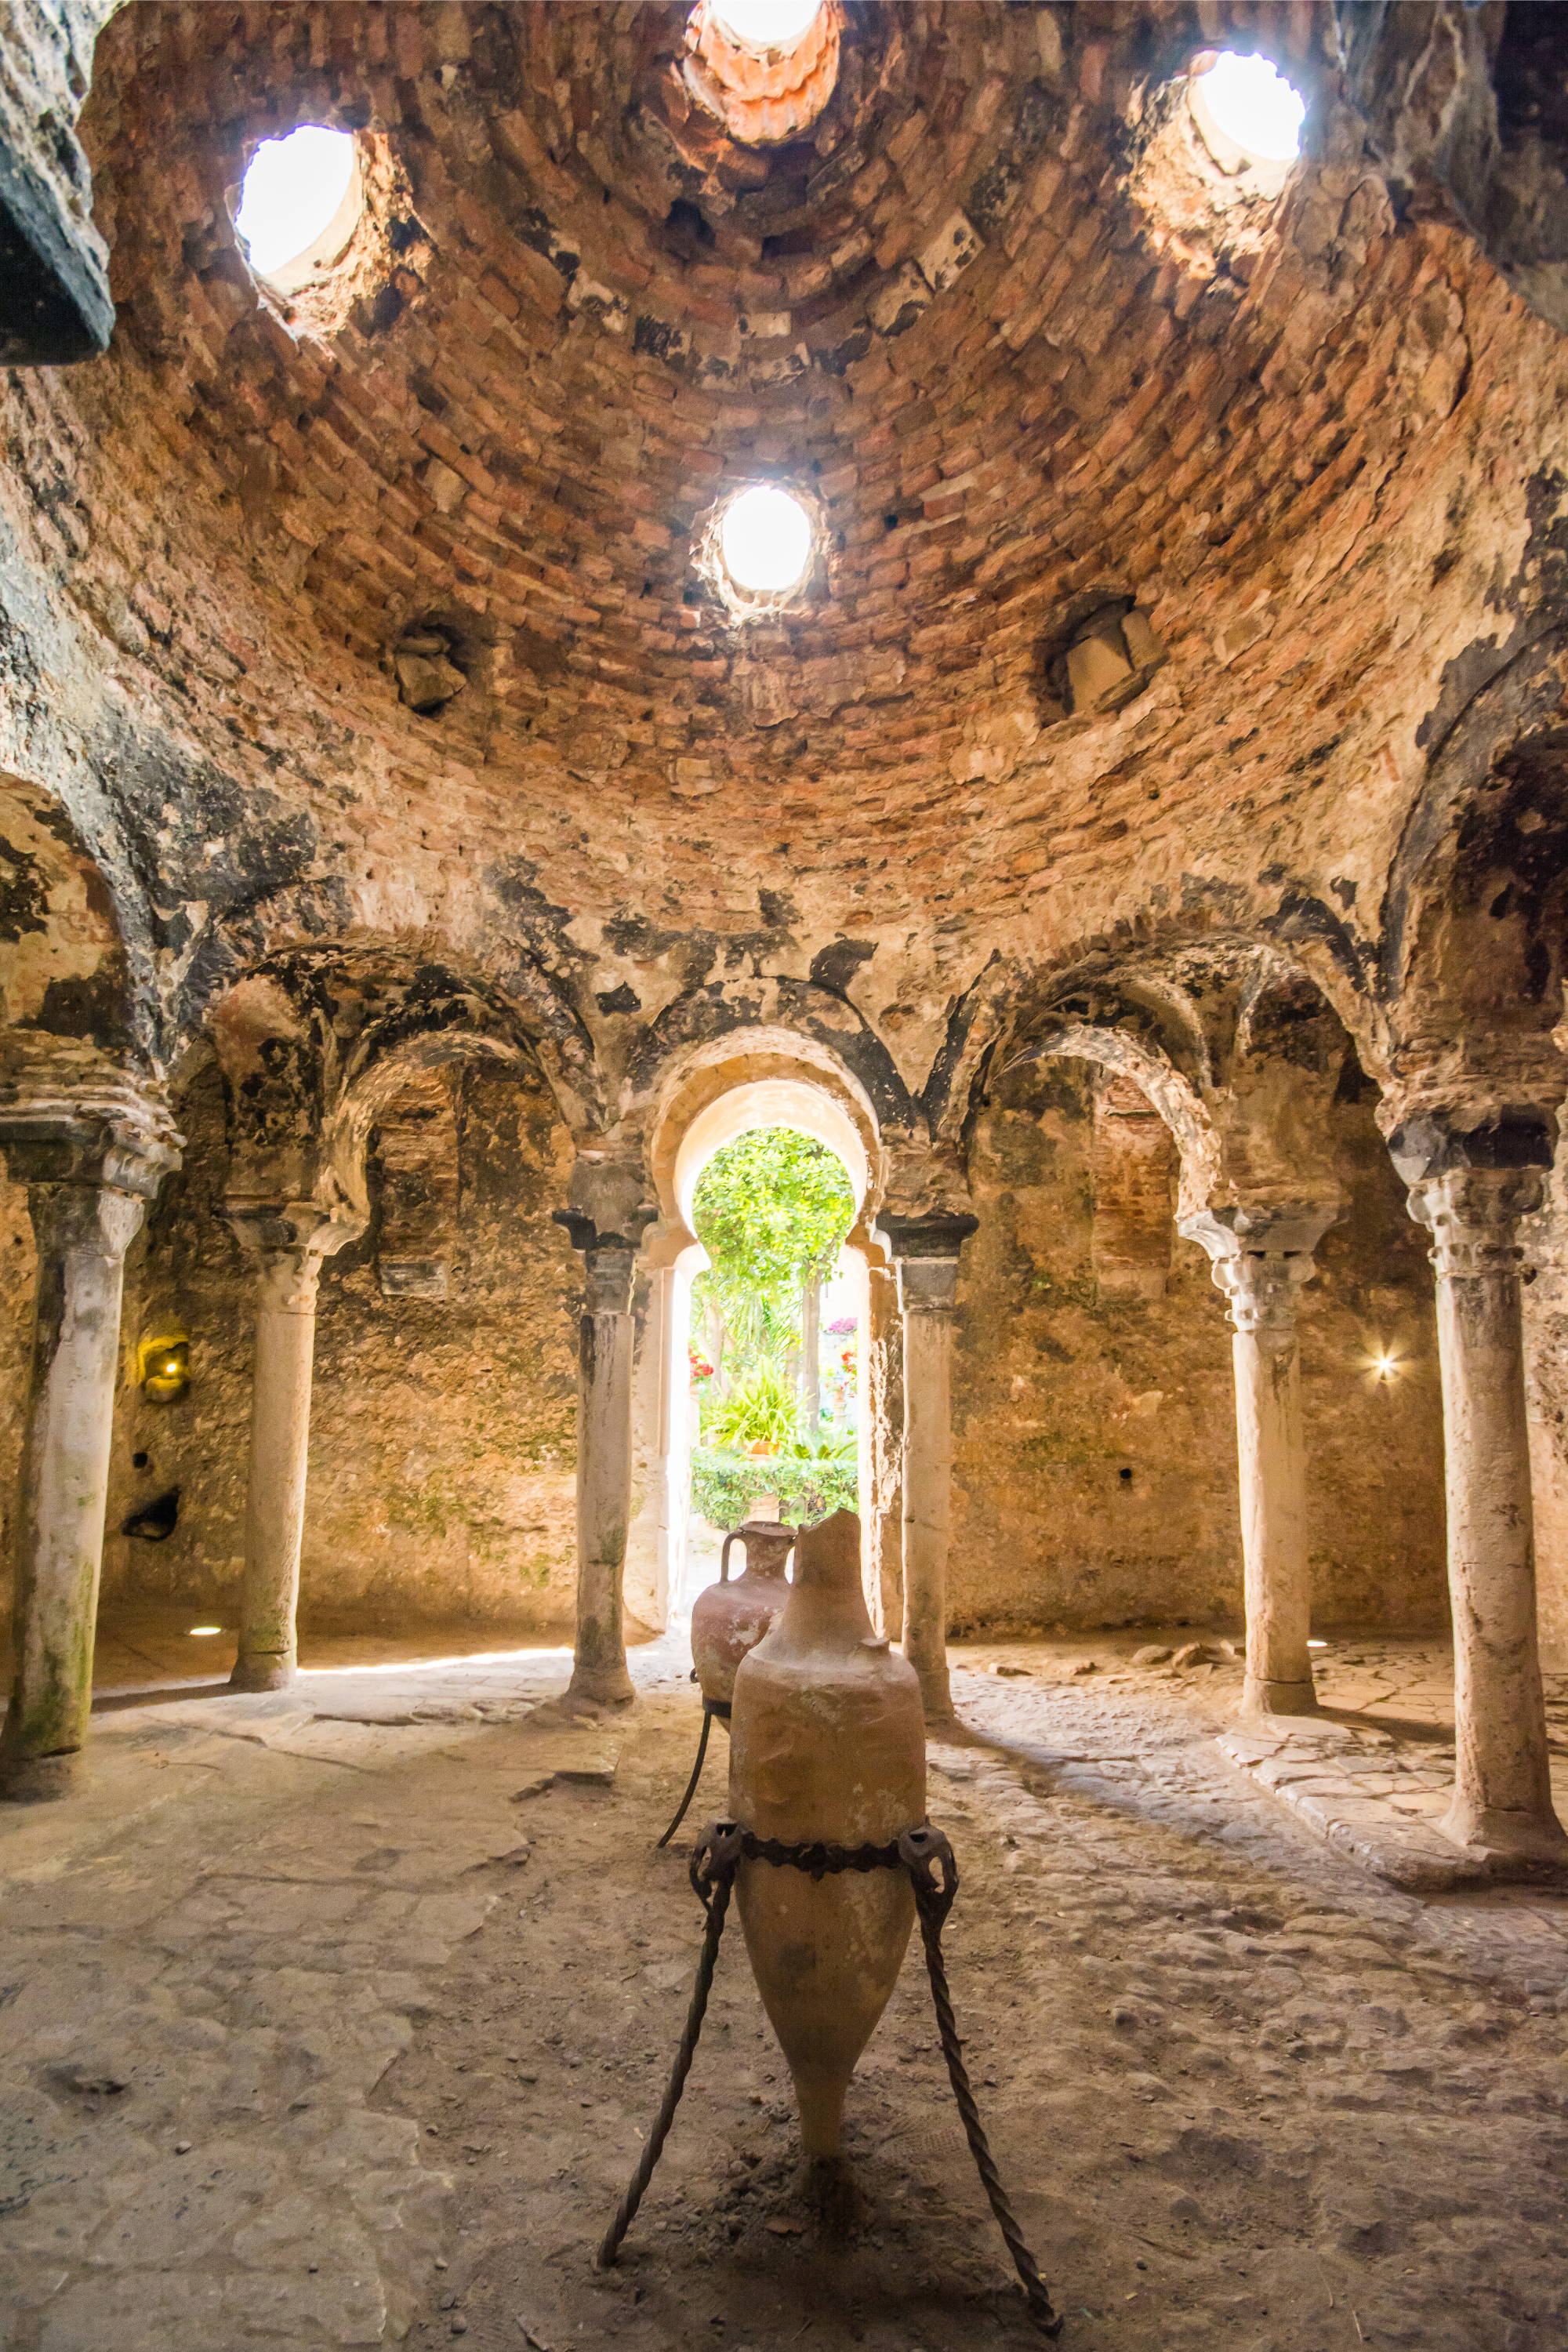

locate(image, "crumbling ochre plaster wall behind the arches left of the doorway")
[[82, 1070, 579, 1632]]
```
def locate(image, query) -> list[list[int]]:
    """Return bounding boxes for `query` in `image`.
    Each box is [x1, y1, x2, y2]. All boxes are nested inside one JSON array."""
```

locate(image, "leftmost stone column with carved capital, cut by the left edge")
[[0, 1108, 179, 1799]]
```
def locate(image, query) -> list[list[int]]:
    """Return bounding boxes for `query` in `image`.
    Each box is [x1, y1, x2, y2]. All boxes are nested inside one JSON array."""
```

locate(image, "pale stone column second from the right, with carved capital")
[[1182, 1204, 1338, 1715]]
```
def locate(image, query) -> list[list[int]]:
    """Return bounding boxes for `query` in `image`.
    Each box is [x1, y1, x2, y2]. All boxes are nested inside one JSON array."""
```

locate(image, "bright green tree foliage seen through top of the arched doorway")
[[691, 1127, 855, 1430]]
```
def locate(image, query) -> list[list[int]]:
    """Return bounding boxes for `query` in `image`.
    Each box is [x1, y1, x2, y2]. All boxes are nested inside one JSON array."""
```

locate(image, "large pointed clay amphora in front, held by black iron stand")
[[729, 1510, 926, 2159]]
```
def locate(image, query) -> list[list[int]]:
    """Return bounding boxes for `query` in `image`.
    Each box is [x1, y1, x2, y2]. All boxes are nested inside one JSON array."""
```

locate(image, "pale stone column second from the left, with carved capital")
[[221, 1202, 365, 1691]]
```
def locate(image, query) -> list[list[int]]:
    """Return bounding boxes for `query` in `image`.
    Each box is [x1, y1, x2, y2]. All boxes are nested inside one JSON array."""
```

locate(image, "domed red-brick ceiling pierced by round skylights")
[[5, 0, 1568, 1091]]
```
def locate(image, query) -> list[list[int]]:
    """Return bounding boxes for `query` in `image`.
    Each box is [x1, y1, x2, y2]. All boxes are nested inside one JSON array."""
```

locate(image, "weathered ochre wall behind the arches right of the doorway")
[[949, 1061, 1446, 1630]]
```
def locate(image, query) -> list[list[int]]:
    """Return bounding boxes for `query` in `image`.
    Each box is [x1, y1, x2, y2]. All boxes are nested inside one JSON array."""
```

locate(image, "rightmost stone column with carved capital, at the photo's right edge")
[[1392, 1167, 1568, 1865]]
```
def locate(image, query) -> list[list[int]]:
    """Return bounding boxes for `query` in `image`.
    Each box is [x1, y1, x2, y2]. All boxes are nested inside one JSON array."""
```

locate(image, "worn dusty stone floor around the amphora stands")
[[0, 1630, 1568, 2352]]
